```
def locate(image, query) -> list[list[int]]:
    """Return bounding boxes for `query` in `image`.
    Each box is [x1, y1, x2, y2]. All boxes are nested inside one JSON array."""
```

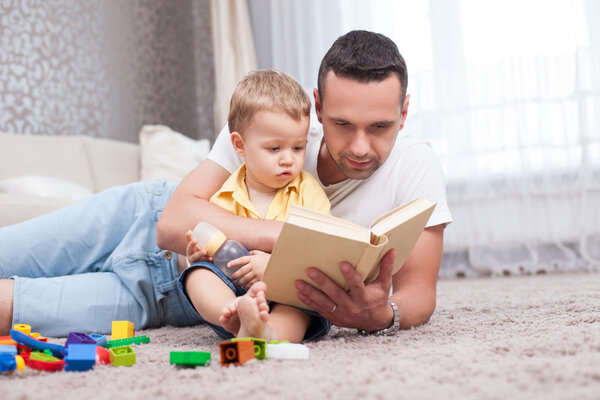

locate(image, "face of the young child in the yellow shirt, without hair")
[[231, 110, 310, 192]]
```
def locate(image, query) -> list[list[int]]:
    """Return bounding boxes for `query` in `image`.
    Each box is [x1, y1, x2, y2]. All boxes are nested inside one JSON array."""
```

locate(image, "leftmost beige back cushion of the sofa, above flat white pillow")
[[0, 132, 95, 191]]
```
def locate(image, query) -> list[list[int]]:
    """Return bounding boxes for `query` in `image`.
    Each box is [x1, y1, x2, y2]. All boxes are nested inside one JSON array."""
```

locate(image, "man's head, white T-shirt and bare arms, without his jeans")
[[157, 31, 452, 334]]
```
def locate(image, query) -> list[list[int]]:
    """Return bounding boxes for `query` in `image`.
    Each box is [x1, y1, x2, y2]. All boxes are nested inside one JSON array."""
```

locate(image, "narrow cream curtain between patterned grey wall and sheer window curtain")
[[210, 0, 257, 133]]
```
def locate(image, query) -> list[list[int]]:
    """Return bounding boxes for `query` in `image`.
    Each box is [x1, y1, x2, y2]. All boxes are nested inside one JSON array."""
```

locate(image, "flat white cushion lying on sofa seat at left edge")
[[0, 175, 92, 201]]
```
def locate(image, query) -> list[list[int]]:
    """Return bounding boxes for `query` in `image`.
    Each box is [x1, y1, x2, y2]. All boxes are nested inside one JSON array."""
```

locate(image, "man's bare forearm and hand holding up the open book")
[[296, 225, 444, 331]]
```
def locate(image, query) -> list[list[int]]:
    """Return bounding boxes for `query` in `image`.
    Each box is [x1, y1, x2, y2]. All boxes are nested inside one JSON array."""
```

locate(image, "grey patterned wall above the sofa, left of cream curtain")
[[0, 0, 215, 142]]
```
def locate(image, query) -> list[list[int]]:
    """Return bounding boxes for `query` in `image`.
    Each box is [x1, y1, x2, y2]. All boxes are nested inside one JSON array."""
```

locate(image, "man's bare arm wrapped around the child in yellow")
[[156, 159, 282, 254]]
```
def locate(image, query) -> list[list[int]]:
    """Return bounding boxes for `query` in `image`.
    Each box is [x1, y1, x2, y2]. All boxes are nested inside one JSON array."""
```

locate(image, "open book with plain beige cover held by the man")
[[262, 199, 435, 308]]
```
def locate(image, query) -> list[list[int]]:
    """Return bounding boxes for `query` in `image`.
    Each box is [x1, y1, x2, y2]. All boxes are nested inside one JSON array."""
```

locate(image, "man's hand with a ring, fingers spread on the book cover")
[[296, 250, 396, 331]]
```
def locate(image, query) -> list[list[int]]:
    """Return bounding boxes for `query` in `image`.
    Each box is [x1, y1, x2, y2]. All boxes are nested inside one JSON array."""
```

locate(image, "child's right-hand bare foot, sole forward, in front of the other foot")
[[236, 282, 272, 340]]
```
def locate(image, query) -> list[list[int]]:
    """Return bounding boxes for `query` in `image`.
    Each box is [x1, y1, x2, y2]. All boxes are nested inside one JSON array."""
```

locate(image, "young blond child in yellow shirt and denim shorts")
[[182, 70, 330, 342]]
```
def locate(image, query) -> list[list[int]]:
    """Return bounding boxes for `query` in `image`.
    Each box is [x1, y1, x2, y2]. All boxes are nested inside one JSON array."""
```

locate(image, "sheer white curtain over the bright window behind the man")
[[250, 0, 600, 276]]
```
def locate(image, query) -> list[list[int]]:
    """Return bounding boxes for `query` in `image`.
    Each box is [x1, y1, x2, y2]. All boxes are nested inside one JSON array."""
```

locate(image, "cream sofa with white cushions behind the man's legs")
[[0, 125, 210, 227]]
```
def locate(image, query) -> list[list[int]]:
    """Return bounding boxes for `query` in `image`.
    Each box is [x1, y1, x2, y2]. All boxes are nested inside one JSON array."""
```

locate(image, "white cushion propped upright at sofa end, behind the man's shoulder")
[[140, 125, 210, 182]]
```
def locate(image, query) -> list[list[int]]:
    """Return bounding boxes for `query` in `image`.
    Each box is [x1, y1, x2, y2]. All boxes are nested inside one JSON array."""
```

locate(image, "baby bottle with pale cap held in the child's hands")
[[192, 221, 249, 277]]
